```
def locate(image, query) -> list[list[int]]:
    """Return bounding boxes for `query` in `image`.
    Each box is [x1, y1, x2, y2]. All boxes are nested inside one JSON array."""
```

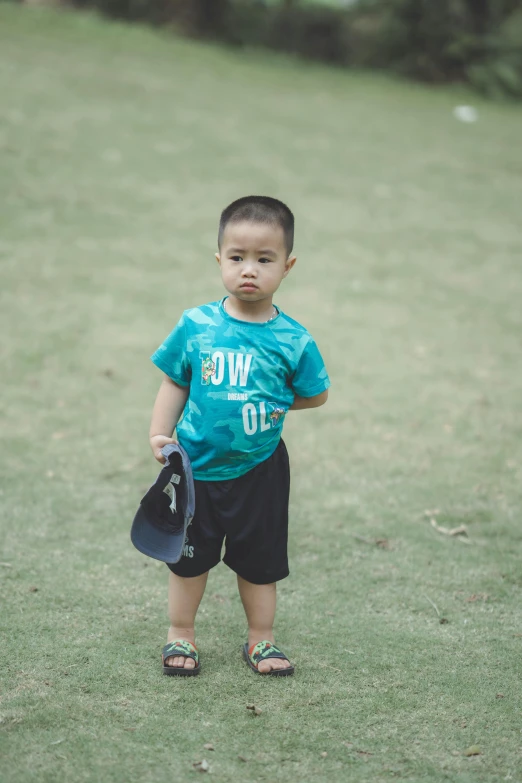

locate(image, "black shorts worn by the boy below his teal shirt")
[[167, 440, 290, 585]]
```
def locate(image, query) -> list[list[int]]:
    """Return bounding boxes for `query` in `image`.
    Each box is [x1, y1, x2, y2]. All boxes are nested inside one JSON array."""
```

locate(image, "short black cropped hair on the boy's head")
[[218, 196, 294, 255]]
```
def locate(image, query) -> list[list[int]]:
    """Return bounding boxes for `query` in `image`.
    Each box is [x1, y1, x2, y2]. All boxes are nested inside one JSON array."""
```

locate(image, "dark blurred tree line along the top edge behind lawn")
[[65, 0, 522, 98]]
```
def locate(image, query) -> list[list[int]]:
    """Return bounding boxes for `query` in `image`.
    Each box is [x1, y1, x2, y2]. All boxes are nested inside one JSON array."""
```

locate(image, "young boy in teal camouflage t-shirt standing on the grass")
[[150, 196, 330, 676]]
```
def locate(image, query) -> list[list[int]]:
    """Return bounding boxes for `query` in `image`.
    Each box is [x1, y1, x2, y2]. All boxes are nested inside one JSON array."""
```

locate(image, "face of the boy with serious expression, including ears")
[[216, 221, 296, 302]]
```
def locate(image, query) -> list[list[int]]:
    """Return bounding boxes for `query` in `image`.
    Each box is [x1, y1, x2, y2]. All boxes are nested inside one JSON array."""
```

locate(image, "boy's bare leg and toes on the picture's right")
[[237, 575, 290, 673]]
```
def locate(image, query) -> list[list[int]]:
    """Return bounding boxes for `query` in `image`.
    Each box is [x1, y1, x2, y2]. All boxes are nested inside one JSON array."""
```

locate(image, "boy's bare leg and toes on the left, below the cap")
[[165, 571, 208, 669]]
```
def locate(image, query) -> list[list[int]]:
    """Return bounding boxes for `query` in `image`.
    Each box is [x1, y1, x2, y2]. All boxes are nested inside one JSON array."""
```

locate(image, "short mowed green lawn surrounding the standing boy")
[[0, 6, 522, 783]]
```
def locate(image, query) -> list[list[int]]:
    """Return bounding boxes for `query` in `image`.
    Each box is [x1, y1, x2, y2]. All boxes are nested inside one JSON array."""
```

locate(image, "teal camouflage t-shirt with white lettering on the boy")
[[151, 299, 330, 481]]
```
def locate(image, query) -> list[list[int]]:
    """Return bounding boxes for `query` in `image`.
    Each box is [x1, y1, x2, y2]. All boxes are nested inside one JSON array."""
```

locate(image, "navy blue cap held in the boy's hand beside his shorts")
[[131, 443, 195, 563]]
